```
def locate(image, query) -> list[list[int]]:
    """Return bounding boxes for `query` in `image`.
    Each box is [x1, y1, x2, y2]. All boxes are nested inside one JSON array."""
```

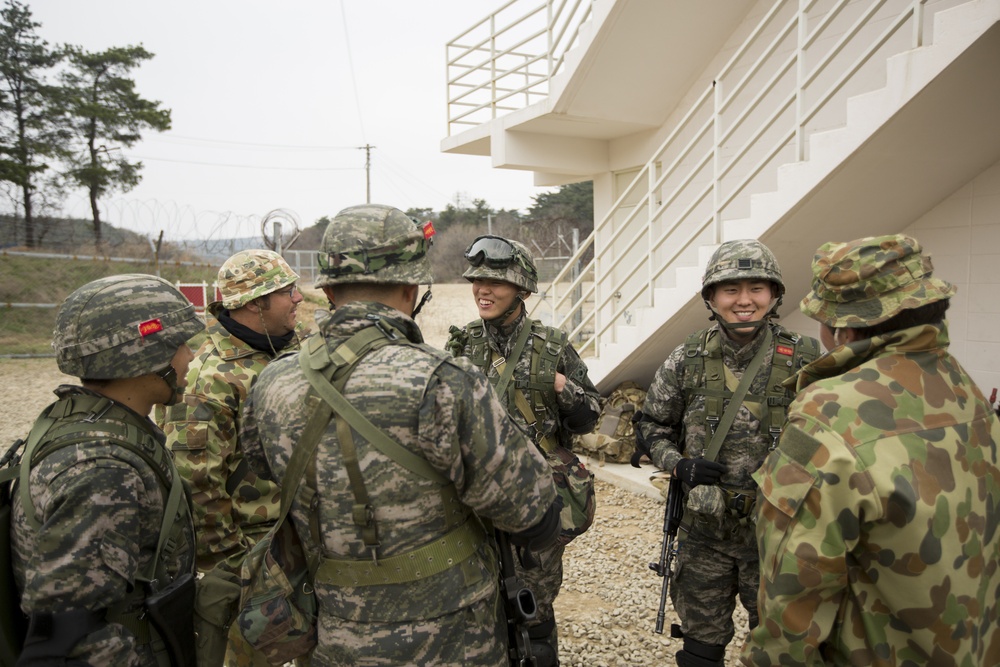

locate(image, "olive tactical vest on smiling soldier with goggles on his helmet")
[[465, 320, 569, 450]]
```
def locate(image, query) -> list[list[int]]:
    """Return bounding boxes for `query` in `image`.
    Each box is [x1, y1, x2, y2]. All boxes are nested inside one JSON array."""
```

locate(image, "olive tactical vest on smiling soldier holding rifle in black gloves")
[[682, 324, 819, 449]]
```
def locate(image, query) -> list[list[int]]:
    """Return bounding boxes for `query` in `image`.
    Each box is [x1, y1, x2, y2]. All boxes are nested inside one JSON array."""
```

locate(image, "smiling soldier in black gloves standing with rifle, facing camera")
[[634, 240, 819, 667]]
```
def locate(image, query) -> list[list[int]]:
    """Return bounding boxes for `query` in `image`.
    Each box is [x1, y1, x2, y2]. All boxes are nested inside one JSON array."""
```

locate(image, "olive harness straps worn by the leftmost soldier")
[[2, 393, 191, 667]]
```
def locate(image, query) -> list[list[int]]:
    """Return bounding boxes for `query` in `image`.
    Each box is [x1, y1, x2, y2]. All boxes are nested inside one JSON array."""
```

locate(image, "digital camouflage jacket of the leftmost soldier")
[[11, 385, 194, 667]]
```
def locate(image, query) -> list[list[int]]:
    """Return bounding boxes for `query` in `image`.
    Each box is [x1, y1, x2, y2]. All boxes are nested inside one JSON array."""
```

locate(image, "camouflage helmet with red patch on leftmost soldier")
[[52, 273, 205, 380]]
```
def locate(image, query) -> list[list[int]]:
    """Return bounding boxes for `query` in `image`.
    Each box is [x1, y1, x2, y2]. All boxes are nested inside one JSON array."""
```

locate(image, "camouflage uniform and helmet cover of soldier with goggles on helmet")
[[445, 239, 600, 659]]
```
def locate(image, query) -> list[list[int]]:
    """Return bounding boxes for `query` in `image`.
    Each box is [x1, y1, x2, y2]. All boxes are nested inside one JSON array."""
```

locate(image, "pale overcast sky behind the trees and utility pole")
[[27, 0, 546, 237]]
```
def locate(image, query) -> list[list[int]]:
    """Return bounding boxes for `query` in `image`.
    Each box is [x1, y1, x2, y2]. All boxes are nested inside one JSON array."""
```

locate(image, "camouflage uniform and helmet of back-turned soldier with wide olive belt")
[[241, 205, 555, 667]]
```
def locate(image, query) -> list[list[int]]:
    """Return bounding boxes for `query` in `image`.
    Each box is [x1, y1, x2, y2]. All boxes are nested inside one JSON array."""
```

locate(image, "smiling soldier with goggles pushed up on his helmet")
[[446, 236, 600, 667]]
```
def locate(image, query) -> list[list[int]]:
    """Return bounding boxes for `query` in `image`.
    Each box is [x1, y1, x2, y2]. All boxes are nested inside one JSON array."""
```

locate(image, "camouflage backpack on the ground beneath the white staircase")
[[573, 380, 646, 463]]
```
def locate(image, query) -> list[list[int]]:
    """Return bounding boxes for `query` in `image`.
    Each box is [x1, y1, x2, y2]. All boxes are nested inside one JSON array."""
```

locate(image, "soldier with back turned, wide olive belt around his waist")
[[242, 204, 561, 667]]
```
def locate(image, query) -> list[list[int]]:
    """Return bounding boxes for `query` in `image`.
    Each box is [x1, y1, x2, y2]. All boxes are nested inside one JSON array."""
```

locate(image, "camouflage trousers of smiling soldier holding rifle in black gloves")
[[670, 526, 760, 646]]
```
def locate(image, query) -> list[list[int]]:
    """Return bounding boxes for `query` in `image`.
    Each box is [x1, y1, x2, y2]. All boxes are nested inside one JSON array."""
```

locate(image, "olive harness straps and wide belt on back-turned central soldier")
[[299, 319, 486, 600]]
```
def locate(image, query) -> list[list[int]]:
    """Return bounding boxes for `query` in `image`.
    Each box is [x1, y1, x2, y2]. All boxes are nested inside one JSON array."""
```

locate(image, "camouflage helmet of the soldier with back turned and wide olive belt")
[[316, 204, 434, 287]]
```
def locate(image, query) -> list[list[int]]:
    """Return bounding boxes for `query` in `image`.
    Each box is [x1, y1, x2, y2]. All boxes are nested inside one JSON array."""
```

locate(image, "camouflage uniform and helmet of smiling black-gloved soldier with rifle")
[[639, 241, 820, 664]]
